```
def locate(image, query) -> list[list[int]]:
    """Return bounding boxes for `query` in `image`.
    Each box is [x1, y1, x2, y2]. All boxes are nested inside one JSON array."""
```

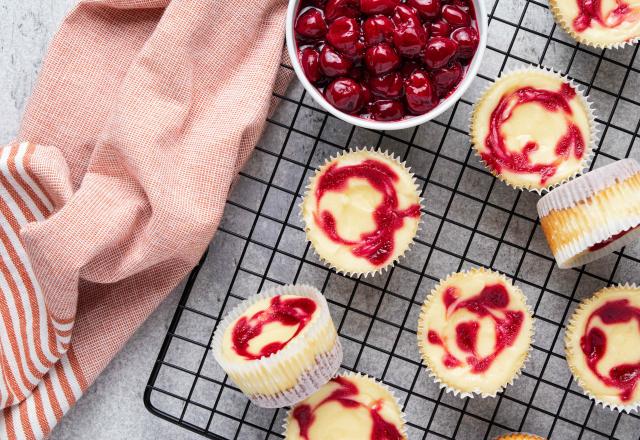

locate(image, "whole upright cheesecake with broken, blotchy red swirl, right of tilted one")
[[418, 268, 533, 397]]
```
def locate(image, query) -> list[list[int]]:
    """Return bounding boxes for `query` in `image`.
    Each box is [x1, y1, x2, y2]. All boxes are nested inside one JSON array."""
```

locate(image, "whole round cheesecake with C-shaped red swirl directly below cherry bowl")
[[302, 150, 420, 274]]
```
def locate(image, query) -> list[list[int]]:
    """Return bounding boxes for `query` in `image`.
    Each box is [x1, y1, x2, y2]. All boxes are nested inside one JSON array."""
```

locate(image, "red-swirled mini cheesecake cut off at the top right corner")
[[549, 0, 640, 48]]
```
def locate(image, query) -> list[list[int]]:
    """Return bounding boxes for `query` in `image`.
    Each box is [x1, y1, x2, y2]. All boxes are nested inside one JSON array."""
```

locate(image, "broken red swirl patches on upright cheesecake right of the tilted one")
[[427, 284, 524, 374]]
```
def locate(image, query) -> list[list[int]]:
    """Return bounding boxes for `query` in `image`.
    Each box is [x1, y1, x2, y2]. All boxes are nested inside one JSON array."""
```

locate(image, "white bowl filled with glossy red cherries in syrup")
[[286, 0, 487, 130]]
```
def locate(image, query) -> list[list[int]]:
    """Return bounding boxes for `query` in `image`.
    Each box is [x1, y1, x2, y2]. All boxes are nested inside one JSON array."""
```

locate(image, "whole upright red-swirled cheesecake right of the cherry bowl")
[[471, 68, 595, 192]]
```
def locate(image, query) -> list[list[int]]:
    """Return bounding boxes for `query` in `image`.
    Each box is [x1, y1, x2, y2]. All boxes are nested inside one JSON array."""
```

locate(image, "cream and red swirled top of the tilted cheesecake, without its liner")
[[222, 295, 319, 363]]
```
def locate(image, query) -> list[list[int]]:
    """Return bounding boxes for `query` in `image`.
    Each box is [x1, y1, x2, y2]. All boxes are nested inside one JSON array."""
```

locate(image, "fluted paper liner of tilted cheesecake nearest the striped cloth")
[[212, 285, 342, 408]]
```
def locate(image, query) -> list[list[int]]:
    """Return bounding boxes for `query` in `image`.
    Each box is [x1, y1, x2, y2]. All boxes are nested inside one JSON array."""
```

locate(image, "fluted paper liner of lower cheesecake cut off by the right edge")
[[564, 283, 640, 413]]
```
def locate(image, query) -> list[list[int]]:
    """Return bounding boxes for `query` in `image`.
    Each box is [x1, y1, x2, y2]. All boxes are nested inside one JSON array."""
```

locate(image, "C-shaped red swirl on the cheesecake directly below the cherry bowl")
[[315, 159, 420, 266]]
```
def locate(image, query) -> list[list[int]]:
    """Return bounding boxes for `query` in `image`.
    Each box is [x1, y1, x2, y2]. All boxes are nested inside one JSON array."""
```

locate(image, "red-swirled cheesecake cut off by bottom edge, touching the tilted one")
[[285, 373, 408, 440]]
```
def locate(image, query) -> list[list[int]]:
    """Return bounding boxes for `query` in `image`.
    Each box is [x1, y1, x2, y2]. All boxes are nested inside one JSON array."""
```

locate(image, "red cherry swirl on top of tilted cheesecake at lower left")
[[231, 296, 317, 360]]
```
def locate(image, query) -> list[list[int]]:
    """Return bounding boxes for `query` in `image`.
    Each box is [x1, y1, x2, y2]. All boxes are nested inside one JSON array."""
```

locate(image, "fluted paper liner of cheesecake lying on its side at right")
[[538, 159, 640, 269]]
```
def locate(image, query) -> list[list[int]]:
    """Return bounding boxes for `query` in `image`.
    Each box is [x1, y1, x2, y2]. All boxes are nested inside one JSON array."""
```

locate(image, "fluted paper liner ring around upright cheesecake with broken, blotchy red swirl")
[[417, 267, 535, 398]]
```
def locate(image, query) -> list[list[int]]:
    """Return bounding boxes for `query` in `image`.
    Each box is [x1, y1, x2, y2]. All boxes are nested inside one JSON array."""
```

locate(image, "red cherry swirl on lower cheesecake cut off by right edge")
[[580, 299, 640, 402]]
